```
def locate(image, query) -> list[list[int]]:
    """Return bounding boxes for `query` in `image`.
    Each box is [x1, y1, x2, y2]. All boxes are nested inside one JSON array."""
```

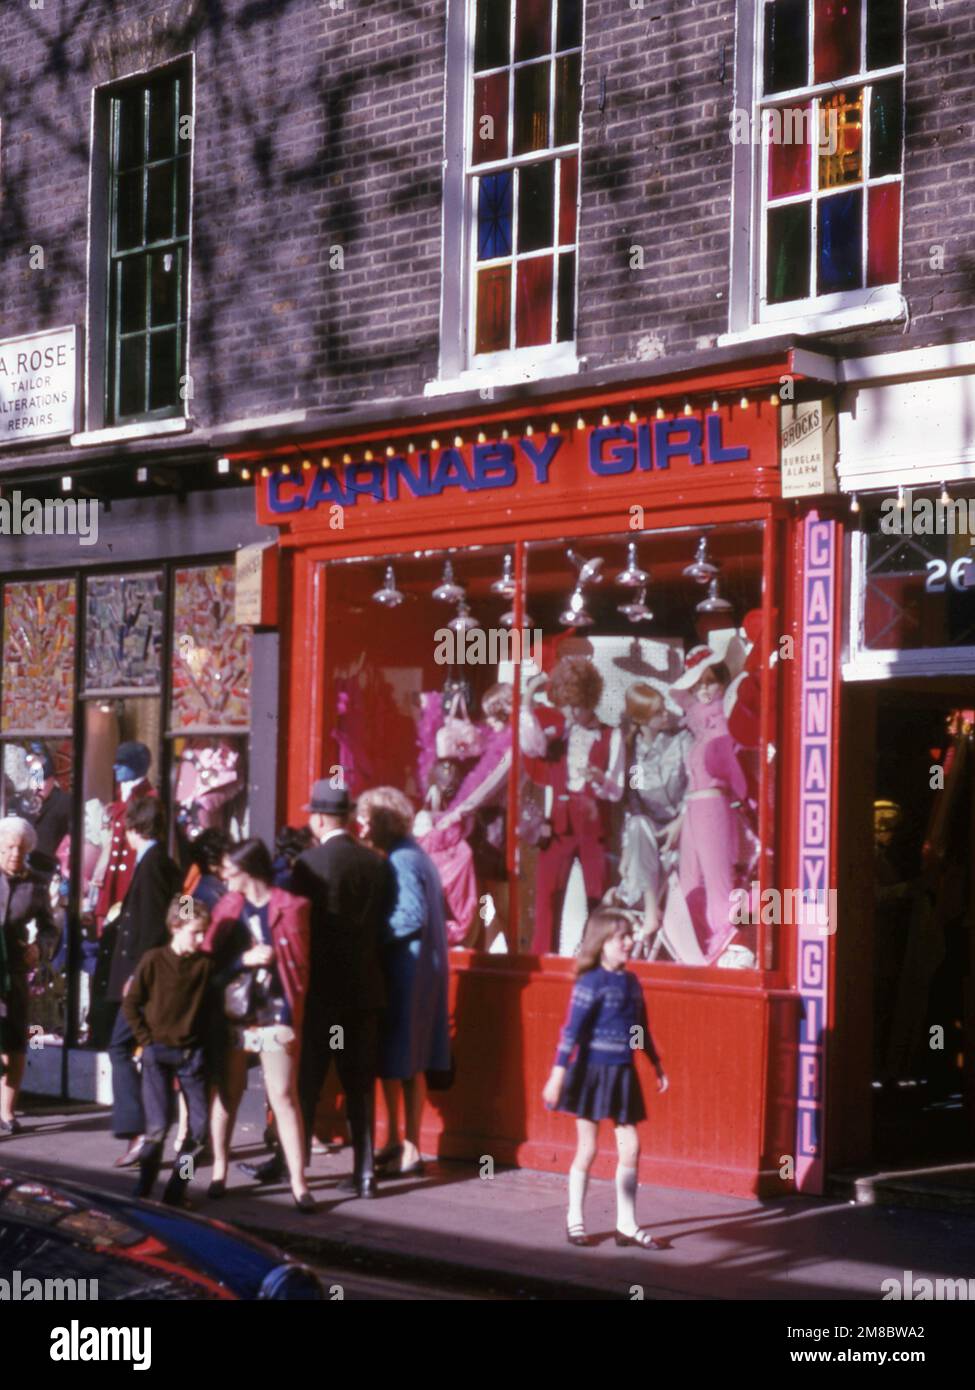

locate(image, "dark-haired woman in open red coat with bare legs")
[[203, 840, 314, 1212]]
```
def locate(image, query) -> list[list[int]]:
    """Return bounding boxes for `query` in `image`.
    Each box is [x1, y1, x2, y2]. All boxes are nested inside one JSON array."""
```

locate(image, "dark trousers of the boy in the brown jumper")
[[138, 1043, 209, 1200]]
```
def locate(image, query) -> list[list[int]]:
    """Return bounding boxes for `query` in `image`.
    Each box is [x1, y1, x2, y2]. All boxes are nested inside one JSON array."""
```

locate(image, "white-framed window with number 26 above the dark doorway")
[[844, 493, 975, 678]]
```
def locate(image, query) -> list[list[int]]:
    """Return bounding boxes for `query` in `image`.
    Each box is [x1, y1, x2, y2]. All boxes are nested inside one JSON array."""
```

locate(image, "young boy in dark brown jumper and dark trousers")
[[122, 895, 213, 1207]]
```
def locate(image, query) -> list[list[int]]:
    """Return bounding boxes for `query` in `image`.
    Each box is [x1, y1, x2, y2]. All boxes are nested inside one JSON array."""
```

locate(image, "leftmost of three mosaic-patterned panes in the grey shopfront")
[[1, 580, 75, 737]]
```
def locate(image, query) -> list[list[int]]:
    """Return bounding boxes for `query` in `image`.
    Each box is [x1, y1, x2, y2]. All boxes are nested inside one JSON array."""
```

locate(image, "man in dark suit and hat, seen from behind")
[[242, 778, 392, 1197]]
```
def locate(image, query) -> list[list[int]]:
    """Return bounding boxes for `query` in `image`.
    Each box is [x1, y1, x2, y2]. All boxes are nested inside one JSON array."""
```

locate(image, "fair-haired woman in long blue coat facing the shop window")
[[356, 787, 451, 1177]]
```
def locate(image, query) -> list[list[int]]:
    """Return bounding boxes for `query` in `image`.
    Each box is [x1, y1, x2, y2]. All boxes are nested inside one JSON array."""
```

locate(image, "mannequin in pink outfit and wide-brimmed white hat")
[[670, 646, 748, 965]]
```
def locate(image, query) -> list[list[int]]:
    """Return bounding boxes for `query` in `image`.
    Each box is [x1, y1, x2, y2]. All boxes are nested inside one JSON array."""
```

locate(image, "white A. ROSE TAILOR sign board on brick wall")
[[0, 324, 78, 446]]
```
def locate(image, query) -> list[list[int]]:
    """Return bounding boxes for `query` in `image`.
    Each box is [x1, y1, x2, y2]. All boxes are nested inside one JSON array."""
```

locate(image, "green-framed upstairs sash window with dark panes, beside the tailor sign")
[[106, 68, 192, 424]]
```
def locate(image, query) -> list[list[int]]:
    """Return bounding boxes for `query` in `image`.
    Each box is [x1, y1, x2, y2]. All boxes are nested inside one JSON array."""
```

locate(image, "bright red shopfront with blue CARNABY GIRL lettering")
[[234, 353, 839, 1195]]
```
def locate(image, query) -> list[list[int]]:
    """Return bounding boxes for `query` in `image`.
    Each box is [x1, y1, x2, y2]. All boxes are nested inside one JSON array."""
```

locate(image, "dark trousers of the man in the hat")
[[298, 1001, 378, 1179]]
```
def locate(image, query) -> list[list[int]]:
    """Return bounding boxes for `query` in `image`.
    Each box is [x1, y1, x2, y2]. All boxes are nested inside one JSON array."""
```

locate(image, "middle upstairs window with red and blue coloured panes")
[[466, 0, 583, 366]]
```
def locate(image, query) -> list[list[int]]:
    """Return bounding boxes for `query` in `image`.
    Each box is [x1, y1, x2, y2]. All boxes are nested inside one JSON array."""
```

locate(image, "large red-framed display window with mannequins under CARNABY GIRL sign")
[[323, 524, 775, 967]]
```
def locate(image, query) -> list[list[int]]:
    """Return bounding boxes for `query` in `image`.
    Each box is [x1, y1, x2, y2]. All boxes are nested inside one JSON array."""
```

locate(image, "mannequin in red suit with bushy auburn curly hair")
[[524, 656, 623, 955]]
